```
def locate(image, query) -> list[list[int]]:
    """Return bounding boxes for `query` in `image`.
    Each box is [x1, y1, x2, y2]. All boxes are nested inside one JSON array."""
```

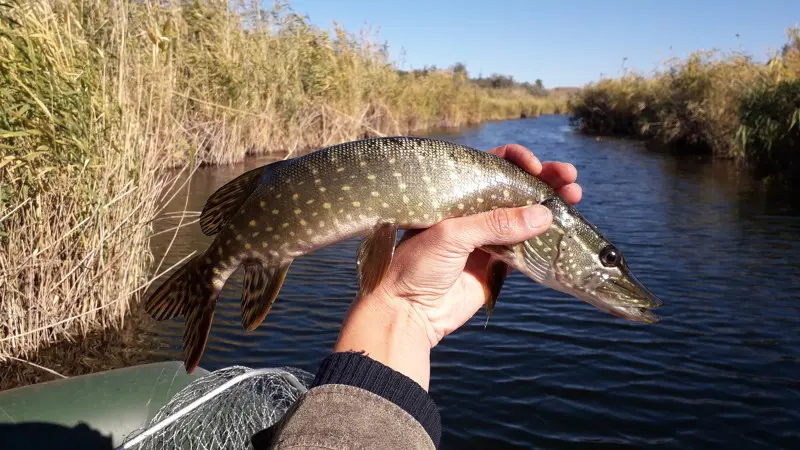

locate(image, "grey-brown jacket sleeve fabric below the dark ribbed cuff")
[[253, 384, 436, 450]]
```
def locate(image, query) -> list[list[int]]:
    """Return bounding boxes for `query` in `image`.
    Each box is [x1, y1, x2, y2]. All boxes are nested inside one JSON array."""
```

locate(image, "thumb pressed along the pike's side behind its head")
[[420, 205, 553, 256]]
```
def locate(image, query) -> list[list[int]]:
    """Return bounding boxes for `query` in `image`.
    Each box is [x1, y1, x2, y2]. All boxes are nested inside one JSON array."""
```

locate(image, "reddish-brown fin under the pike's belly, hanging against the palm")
[[357, 223, 397, 297]]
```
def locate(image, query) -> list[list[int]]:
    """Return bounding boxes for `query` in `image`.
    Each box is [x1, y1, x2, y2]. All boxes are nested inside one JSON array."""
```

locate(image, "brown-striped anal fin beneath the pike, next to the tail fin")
[[242, 261, 292, 331]]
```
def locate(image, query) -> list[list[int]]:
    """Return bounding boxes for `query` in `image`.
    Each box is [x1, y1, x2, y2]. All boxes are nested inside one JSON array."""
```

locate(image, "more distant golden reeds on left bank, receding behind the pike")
[[122, 0, 564, 167]]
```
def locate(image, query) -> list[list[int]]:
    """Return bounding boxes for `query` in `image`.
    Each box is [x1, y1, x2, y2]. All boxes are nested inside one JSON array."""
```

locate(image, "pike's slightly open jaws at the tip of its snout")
[[580, 270, 664, 324]]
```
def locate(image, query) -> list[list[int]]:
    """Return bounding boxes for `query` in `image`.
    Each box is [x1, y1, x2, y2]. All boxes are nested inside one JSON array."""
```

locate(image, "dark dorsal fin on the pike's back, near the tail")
[[200, 161, 285, 236]]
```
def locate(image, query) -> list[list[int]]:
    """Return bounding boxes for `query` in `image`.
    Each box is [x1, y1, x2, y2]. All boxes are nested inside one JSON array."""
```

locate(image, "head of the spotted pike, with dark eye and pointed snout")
[[521, 198, 662, 323]]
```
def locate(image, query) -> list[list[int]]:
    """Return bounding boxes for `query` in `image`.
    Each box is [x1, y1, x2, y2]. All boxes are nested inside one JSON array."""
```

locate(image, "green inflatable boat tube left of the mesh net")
[[0, 361, 209, 450]]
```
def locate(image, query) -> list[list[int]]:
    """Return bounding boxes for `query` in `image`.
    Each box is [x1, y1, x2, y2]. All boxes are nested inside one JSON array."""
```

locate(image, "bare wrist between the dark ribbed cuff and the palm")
[[334, 293, 431, 390]]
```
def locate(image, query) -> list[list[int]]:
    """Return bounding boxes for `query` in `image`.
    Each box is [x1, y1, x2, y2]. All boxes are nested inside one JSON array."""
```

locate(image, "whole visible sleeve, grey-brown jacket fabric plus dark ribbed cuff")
[[252, 344, 442, 450]]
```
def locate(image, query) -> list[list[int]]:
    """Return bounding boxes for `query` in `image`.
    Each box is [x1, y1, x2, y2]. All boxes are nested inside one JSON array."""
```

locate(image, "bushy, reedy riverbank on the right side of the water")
[[570, 28, 800, 182]]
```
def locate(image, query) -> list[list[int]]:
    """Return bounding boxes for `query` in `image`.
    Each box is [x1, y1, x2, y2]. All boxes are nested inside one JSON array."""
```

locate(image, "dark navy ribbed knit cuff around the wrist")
[[311, 352, 442, 448]]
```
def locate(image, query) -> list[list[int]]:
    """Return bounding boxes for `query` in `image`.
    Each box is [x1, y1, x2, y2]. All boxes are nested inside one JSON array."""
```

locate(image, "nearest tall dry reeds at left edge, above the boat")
[[0, 1, 184, 366]]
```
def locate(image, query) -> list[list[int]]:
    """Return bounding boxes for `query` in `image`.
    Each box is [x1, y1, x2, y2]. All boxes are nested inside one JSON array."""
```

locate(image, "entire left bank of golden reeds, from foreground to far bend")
[[0, 0, 565, 380]]
